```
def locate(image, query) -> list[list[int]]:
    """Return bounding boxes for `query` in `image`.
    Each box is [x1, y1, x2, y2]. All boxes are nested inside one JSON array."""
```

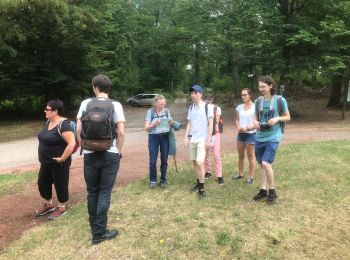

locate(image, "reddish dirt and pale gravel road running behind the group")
[[0, 99, 350, 250]]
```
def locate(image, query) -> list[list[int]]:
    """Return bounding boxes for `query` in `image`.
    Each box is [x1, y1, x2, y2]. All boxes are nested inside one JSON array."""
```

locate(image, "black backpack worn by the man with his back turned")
[[80, 98, 117, 151]]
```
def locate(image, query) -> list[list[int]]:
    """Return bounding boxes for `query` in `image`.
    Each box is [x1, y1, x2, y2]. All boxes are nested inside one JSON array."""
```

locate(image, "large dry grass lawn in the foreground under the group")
[[0, 140, 350, 259]]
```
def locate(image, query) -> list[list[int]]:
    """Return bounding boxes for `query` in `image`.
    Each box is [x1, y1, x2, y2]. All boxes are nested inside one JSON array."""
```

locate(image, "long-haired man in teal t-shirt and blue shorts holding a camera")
[[253, 76, 290, 202]]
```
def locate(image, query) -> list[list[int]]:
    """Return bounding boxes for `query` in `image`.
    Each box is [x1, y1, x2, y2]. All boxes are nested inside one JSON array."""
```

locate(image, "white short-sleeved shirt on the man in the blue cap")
[[187, 101, 214, 143]]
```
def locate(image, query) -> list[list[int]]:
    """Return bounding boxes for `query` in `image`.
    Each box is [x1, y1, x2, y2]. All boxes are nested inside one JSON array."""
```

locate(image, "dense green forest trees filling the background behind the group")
[[0, 0, 350, 118]]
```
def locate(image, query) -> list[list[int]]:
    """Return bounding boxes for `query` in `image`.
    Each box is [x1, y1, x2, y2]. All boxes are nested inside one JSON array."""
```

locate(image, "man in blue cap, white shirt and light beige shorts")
[[184, 85, 214, 199]]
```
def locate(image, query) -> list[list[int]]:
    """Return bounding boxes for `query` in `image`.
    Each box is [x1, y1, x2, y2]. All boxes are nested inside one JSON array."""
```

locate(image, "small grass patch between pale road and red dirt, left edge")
[[0, 172, 37, 196]]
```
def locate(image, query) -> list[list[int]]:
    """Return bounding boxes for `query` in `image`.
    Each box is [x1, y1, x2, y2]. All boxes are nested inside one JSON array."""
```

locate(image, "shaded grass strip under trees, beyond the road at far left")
[[0, 120, 45, 143]]
